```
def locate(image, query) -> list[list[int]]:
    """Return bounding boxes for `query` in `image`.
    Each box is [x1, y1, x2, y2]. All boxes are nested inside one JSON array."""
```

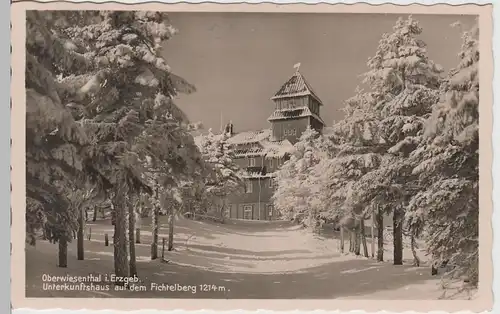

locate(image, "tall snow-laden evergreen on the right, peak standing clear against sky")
[[354, 17, 442, 264]]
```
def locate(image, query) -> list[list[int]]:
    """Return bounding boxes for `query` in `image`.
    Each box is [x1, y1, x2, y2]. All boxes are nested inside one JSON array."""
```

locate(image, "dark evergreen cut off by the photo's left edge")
[[26, 11, 93, 267]]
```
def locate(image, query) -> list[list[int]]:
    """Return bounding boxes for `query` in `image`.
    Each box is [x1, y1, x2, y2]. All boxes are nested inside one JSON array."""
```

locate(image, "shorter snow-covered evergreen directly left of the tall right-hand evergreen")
[[316, 89, 386, 255]]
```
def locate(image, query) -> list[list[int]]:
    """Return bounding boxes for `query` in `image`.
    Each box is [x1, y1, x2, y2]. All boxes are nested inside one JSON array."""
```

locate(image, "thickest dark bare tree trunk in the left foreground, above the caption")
[[113, 193, 128, 285]]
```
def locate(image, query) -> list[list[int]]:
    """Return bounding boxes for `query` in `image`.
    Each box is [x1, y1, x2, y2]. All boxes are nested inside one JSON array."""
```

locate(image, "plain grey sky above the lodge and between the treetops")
[[164, 13, 475, 131]]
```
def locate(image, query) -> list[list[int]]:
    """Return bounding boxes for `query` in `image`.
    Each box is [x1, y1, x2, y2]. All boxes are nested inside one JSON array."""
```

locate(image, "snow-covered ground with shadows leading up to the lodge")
[[26, 217, 470, 299]]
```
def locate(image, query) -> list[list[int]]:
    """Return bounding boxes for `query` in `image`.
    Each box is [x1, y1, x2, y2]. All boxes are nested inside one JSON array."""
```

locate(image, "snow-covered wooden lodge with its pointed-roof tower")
[[195, 70, 325, 220]]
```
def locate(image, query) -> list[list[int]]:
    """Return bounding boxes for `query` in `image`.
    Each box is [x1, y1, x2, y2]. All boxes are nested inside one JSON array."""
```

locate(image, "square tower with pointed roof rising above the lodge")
[[268, 67, 325, 144]]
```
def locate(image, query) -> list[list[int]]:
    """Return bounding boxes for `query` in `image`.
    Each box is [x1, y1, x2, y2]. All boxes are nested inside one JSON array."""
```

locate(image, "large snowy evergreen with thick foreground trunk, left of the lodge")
[[47, 11, 200, 276]]
